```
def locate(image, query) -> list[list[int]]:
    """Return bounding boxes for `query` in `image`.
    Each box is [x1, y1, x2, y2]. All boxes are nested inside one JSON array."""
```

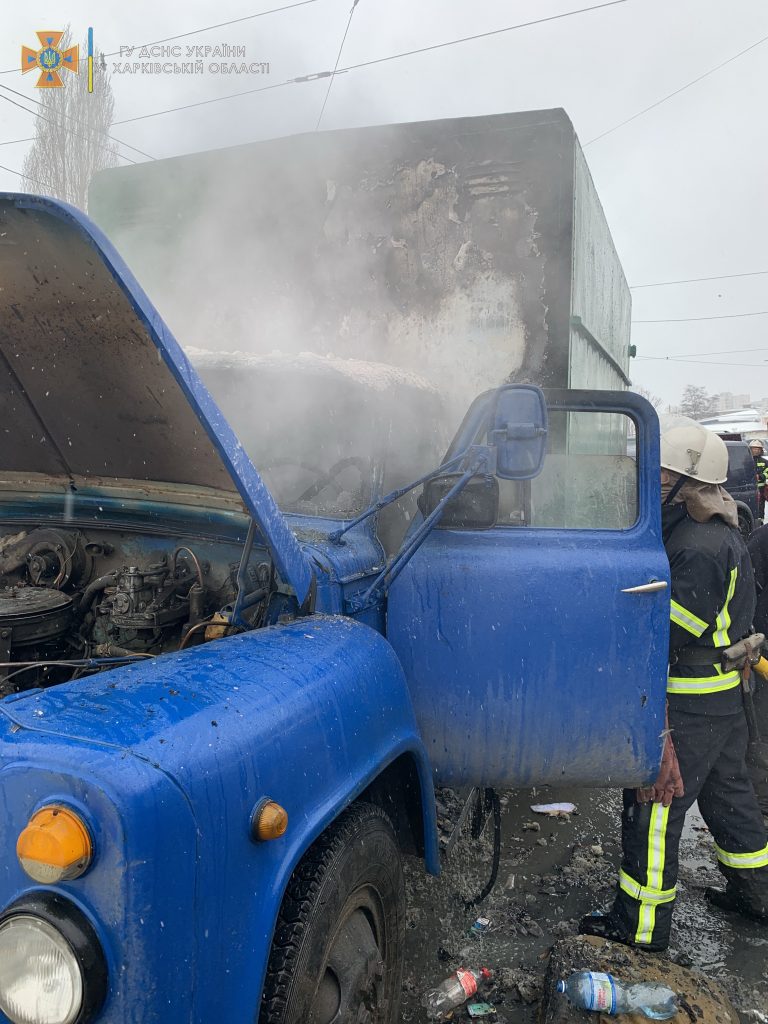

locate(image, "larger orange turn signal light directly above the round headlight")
[[16, 804, 93, 885]]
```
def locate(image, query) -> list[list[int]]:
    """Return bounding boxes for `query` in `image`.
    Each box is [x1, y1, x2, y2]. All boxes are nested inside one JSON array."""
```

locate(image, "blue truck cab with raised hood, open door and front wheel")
[[0, 116, 669, 1024]]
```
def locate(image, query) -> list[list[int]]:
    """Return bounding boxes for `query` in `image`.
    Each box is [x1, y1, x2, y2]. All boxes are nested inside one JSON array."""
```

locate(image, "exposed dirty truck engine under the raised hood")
[[0, 526, 270, 697]]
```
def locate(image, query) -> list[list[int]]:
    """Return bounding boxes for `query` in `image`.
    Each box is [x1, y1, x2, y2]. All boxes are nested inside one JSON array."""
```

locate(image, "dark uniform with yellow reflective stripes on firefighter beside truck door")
[[610, 504, 768, 949]]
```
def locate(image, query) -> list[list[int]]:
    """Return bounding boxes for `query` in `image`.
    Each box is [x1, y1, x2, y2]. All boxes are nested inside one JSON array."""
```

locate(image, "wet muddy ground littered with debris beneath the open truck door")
[[400, 788, 768, 1024]]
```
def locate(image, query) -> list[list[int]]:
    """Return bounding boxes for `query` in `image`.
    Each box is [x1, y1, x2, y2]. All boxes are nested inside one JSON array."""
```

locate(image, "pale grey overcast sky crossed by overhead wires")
[[0, 0, 768, 402]]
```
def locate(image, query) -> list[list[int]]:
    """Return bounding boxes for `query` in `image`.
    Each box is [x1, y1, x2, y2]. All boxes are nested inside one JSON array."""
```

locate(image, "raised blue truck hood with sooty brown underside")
[[0, 193, 311, 602]]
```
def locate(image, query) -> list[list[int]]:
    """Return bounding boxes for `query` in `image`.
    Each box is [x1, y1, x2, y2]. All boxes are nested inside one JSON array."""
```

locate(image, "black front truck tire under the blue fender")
[[259, 804, 406, 1024]]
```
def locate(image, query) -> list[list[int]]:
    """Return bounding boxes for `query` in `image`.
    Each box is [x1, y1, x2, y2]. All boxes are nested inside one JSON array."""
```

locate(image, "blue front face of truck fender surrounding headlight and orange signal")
[[0, 749, 200, 1024]]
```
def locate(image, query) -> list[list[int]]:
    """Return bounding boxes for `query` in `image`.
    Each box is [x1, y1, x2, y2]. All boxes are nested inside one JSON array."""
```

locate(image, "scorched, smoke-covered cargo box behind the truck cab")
[[90, 110, 630, 428]]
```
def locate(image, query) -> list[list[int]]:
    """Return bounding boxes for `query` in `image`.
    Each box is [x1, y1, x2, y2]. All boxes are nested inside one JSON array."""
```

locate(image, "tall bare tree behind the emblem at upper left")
[[22, 27, 118, 210]]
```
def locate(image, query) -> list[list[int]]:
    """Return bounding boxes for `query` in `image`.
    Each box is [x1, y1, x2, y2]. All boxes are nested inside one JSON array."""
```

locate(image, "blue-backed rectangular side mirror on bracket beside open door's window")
[[488, 384, 548, 480]]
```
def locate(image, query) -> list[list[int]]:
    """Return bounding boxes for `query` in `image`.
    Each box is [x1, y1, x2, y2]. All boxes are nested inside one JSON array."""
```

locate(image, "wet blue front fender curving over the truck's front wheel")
[[0, 615, 438, 1024]]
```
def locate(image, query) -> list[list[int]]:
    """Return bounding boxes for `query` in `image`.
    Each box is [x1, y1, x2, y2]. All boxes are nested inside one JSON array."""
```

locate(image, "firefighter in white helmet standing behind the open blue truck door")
[[580, 417, 768, 950]]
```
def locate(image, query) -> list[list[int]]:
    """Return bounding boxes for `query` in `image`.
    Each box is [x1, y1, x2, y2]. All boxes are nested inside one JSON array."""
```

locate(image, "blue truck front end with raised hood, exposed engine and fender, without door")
[[0, 196, 438, 1024]]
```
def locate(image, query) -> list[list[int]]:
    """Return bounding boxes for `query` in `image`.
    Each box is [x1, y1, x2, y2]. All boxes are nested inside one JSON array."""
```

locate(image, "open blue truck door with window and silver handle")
[[388, 391, 670, 786]]
